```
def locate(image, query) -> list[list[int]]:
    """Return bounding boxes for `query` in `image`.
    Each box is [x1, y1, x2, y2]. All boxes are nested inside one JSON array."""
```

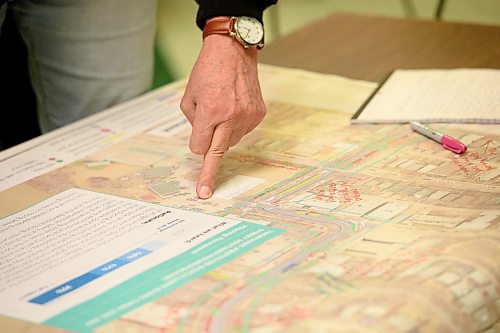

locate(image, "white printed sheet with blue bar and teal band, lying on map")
[[0, 188, 283, 332]]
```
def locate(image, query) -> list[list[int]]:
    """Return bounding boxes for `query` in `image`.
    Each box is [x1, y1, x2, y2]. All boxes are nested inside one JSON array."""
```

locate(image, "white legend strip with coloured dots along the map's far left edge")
[[0, 90, 186, 191]]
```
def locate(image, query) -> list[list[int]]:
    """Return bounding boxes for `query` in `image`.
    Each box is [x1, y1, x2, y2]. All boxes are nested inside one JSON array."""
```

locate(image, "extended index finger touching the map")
[[196, 123, 232, 199]]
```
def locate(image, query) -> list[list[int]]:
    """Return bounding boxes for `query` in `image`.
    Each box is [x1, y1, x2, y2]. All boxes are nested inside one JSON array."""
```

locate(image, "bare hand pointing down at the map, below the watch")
[[181, 35, 266, 199]]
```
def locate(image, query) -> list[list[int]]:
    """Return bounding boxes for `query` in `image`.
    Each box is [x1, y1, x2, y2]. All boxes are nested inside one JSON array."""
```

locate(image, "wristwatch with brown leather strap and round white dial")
[[203, 16, 264, 50]]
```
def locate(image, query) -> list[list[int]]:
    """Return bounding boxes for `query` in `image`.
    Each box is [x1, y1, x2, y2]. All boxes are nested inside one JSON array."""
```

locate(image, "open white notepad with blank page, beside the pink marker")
[[351, 68, 500, 124]]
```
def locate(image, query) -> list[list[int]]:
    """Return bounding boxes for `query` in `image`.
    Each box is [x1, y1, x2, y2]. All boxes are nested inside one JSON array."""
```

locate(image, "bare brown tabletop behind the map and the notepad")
[[260, 14, 500, 82]]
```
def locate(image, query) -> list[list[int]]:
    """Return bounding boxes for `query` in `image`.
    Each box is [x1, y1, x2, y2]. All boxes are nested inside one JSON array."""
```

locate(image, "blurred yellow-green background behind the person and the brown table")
[[153, 0, 500, 87]]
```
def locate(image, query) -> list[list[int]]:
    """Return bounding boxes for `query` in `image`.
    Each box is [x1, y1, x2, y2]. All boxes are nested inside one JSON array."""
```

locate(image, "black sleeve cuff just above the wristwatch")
[[196, 0, 278, 30]]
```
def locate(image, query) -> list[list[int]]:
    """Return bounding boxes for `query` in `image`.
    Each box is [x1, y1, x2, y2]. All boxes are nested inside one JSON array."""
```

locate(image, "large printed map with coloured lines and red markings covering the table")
[[0, 66, 500, 332]]
